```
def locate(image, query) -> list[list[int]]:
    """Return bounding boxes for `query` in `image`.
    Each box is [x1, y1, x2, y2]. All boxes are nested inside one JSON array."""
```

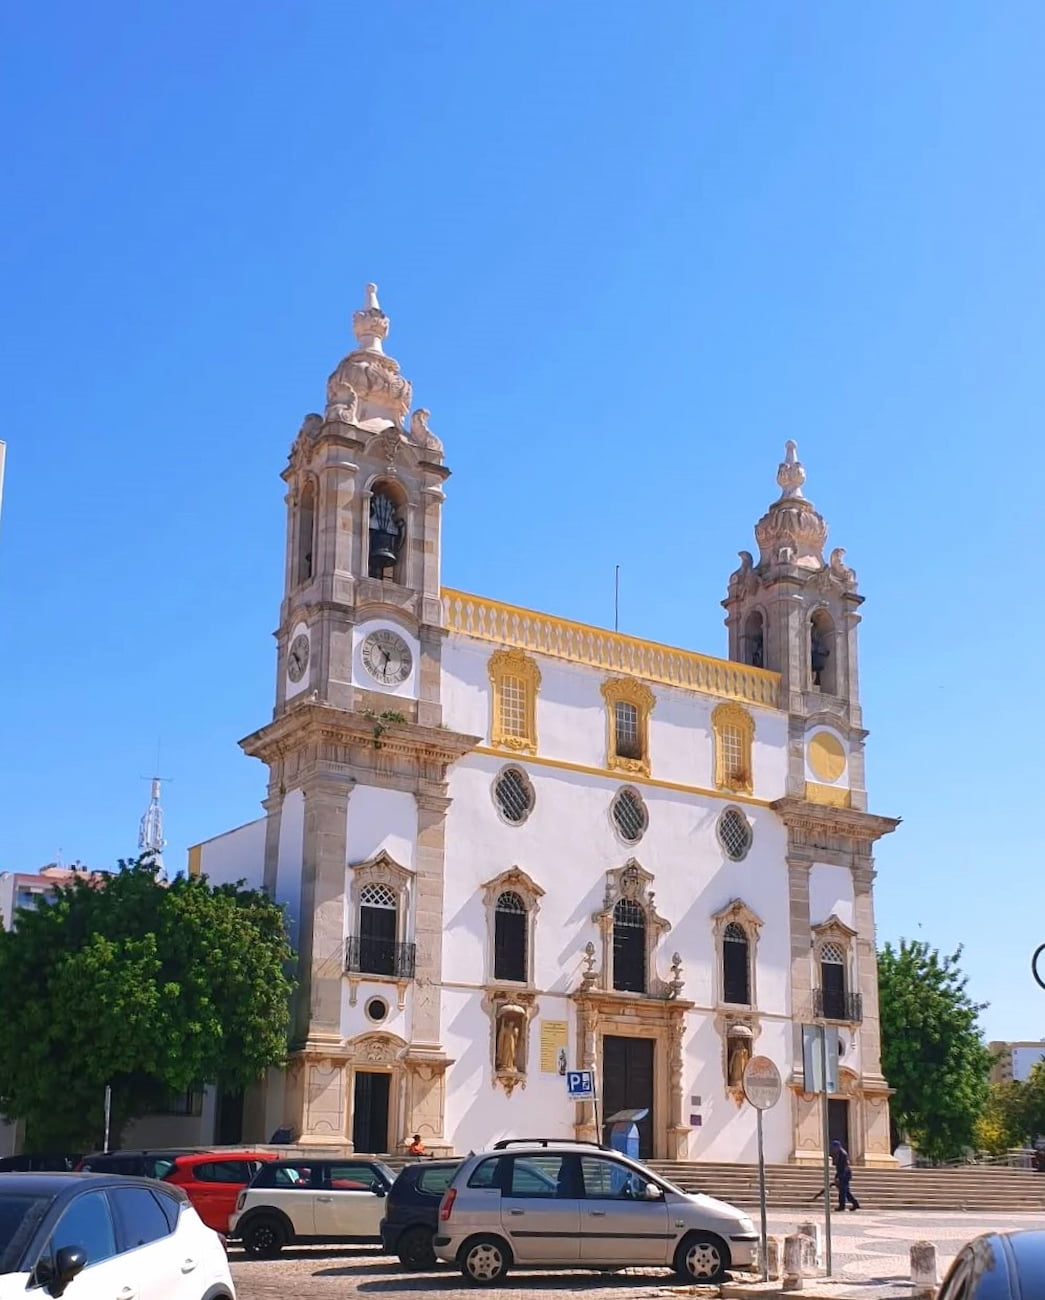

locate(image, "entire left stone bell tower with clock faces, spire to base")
[[240, 285, 477, 1144]]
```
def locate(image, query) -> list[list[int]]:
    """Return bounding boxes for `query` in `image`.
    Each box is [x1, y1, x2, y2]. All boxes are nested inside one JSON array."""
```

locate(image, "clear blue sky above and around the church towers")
[[0, 0, 1045, 1037]]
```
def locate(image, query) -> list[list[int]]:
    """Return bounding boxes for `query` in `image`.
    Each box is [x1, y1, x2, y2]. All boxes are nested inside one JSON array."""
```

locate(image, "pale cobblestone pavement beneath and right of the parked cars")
[[230, 1208, 1042, 1300]]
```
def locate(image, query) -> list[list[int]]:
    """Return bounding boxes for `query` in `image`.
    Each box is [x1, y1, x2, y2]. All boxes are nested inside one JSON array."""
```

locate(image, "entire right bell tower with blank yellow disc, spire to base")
[[723, 442, 898, 1166]]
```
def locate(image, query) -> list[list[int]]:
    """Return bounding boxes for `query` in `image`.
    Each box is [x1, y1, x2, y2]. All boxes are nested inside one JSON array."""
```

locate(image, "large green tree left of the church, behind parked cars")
[[0, 858, 294, 1151]]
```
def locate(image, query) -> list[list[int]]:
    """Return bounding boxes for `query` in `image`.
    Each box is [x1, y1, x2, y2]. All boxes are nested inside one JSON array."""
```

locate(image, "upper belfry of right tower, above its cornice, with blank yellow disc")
[[723, 442, 867, 809]]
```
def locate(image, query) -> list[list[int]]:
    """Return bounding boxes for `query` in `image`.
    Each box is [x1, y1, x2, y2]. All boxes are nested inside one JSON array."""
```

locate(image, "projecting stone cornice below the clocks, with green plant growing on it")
[[239, 699, 480, 771]]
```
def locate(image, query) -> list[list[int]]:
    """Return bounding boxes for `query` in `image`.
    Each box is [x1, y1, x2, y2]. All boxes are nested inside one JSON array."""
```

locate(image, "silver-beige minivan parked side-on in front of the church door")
[[433, 1139, 758, 1286]]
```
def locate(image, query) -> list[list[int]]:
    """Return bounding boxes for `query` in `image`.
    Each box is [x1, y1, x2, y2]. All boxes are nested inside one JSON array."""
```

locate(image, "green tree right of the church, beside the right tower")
[[879, 939, 992, 1160]]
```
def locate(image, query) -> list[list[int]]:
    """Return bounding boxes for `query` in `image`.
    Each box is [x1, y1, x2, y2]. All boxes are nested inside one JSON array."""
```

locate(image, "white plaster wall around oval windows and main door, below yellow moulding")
[[443, 754, 792, 1161]]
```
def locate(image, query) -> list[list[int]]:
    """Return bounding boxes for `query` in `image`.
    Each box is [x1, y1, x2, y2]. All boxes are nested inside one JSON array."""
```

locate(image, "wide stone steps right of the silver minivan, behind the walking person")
[[650, 1161, 1045, 1213]]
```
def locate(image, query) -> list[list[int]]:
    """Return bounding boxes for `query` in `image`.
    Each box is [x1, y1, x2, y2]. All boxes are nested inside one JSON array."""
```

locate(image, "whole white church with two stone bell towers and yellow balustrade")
[[190, 286, 896, 1165]]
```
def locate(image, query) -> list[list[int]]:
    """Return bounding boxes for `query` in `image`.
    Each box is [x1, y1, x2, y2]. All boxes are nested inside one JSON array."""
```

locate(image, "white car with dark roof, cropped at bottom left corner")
[[0, 1174, 235, 1300]]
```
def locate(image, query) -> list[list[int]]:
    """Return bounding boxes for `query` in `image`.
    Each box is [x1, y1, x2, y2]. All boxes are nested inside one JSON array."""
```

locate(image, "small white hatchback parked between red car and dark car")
[[229, 1156, 395, 1257]]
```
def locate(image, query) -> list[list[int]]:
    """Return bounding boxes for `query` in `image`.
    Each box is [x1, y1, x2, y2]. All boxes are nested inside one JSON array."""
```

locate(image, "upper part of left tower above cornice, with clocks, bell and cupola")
[[276, 285, 448, 725]]
